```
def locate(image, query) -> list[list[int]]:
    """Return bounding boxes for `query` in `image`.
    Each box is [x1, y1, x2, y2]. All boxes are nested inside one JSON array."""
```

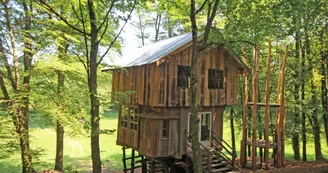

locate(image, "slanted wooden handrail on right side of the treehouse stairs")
[[212, 130, 237, 168]]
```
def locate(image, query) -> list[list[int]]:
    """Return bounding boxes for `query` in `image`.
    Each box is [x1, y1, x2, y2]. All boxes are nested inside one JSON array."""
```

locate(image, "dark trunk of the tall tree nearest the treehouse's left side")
[[88, 0, 101, 173]]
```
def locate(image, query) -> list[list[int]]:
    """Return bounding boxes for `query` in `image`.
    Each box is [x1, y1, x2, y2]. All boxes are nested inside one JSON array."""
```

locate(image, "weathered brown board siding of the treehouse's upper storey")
[[112, 47, 238, 107]]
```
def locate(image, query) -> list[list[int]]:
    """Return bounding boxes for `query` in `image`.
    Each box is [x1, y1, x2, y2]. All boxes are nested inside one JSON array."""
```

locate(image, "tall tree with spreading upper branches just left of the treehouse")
[[38, 0, 136, 173]]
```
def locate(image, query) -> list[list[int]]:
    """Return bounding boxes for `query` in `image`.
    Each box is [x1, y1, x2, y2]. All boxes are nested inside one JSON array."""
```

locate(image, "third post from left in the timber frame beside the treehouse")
[[264, 41, 271, 169]]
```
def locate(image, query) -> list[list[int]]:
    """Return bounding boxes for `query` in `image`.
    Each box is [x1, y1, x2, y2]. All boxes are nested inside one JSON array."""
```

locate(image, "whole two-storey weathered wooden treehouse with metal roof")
[[103, 33, 247, 171]]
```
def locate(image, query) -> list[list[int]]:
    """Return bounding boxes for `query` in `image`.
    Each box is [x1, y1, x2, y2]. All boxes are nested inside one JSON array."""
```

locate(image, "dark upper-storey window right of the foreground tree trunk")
[[208, 69, 223, 89]]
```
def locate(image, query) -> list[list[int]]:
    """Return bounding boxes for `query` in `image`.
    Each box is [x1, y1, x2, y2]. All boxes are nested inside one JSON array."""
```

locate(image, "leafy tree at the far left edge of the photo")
[[0, 0, 34, 173]]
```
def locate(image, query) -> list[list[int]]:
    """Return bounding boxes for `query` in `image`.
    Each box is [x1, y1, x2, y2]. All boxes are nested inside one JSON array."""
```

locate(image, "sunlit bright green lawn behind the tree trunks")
[[0, 113, 328, 173]]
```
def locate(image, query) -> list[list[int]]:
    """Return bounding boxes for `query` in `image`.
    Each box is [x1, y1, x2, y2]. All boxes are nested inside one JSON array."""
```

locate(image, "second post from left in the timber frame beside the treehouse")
[[252, 46, 259, 169]]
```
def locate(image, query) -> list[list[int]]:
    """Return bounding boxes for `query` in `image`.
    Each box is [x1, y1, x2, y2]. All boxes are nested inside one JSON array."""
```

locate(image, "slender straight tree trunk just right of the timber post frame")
[[292, 31, 301, 160]]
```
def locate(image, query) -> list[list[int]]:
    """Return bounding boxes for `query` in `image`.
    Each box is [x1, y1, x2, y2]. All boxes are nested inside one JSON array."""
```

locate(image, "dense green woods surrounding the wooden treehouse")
[[0, 0, 328, 173]]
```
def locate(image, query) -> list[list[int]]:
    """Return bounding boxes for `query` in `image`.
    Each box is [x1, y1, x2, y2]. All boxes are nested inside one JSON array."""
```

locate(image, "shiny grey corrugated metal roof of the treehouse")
[[124, 32, 192, 67]]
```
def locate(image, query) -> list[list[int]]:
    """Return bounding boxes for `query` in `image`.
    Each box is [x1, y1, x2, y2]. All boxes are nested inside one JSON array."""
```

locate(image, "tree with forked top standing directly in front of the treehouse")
[[190, 0, 219, 173]]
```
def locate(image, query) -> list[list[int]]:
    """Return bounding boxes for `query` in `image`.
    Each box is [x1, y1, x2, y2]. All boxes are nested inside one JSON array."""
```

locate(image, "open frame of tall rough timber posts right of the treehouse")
[[240, 42, 288, 169]]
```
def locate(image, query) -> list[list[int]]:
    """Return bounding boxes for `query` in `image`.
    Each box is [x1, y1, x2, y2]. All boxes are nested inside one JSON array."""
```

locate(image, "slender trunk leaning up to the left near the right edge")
[[305, 33, 324, 160]]
